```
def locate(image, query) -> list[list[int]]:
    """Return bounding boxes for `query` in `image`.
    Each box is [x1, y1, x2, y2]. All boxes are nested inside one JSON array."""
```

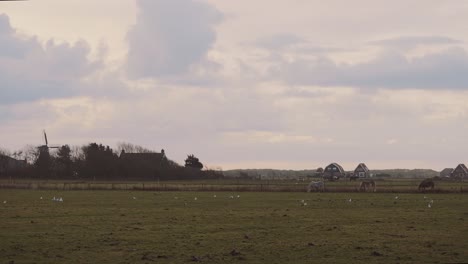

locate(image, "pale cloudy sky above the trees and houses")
[[0, 0, 468, 170]]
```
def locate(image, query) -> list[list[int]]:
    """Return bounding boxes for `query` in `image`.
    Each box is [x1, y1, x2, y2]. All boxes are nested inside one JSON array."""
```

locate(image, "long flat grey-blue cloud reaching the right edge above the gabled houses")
[[270, 48, 468, 90]]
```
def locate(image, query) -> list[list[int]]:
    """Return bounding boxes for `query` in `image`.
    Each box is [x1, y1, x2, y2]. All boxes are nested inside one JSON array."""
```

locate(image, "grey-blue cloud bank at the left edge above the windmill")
[[0, 15, 100, 104]]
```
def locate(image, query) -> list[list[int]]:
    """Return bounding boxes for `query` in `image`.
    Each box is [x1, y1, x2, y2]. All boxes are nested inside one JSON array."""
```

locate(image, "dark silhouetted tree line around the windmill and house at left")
[[0, 142, 223, 181]]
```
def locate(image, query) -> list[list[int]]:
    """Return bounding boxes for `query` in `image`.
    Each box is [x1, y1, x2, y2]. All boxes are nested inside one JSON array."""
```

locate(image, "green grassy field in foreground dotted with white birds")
[[0, 190, 468, 263]]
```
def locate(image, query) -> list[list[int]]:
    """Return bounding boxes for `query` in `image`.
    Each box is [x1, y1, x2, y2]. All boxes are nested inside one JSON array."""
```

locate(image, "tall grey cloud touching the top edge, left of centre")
[[127, 0, 223, 79]]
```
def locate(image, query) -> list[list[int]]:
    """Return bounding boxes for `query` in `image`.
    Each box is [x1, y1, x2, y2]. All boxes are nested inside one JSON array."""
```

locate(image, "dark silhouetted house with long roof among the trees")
[[119, 149, 167, 180]]
